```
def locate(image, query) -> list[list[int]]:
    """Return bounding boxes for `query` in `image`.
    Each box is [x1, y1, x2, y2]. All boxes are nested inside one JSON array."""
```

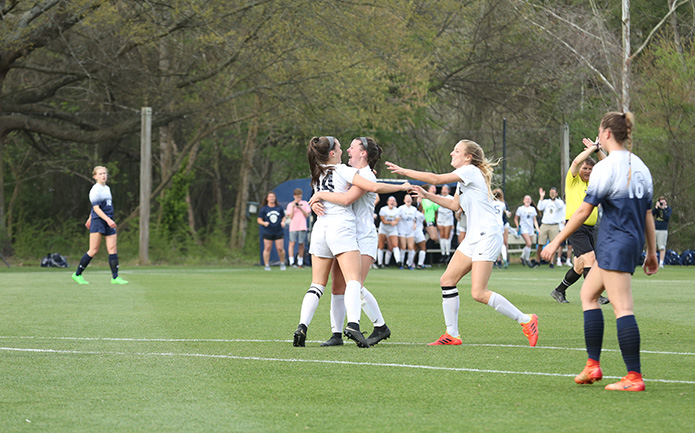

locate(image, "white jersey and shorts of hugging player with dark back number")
[[309, 164, 359, 258]]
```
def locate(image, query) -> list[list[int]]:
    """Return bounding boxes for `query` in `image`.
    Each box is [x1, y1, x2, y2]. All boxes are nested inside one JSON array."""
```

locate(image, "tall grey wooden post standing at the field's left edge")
[[140, 107, 152, 265]]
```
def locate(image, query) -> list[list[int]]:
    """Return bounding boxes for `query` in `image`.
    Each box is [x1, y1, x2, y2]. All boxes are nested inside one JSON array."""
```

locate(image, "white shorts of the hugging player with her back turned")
[[309, 218, 359, 259]]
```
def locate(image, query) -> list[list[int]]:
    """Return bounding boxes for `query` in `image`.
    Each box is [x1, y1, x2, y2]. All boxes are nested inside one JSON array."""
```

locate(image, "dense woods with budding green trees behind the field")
[[0, 0, 695, 261]]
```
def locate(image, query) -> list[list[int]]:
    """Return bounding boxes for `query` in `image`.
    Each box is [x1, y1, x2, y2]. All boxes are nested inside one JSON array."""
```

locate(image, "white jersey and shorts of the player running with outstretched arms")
[[454, 165, 503, 262]]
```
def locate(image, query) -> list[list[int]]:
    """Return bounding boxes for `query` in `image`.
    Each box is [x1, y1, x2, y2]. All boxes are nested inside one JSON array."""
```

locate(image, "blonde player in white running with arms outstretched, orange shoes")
[[386, 140, 538, 346]]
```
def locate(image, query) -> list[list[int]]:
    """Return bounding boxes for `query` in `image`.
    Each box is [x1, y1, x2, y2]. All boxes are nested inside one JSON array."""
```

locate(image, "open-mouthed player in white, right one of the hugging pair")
[[311, 137, 409, 346]]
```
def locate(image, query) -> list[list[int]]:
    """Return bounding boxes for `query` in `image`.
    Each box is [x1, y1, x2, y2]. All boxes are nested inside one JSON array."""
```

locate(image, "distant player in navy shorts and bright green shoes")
[[72, 165, 128, 284]]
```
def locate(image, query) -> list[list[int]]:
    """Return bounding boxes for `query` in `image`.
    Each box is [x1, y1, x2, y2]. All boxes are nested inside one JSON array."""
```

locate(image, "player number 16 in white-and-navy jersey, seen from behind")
[[542, 112, 659, 391]]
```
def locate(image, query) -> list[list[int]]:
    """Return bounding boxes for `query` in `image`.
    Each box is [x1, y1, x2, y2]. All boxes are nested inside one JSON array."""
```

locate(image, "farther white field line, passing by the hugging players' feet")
[[0, 335, 695, 356]]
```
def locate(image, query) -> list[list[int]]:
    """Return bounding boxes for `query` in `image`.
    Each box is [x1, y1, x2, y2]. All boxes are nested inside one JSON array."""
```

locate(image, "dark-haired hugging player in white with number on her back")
[[293, 136, 403, 347]]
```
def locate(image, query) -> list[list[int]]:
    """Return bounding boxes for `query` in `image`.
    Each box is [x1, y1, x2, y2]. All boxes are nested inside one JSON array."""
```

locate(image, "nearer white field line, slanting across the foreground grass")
[[0, 347, 695, 385]]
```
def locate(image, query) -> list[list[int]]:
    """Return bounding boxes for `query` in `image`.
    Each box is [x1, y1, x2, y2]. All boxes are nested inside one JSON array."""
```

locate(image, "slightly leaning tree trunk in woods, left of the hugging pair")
[[230, 94, 261, 250]]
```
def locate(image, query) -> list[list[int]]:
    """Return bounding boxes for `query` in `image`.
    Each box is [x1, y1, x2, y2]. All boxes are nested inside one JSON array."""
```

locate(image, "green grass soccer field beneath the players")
[[0, 265, 695, 432]]
